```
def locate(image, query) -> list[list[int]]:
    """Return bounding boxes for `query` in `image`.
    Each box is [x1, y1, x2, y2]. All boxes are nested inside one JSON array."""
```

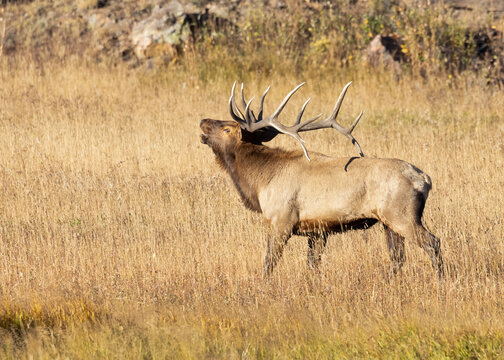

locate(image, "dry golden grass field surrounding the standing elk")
[[0, 59, 504, 359]]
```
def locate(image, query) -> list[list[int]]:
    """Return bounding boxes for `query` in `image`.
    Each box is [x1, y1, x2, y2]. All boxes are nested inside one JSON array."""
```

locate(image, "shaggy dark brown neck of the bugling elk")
[[215, 142, 300, 213]]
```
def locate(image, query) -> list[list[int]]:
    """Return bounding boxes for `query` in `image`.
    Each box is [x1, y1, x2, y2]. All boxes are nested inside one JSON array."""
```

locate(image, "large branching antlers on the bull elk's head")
[[229, 82, 364, 160]]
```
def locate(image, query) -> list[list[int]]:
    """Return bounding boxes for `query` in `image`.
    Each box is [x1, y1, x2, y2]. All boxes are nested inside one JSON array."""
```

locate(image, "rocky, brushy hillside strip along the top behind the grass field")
[[0, 0, 504, 82]]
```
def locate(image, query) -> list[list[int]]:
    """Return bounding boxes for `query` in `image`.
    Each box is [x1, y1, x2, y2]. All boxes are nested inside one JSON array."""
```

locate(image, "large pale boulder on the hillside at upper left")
[[131, 1, 190, 60]]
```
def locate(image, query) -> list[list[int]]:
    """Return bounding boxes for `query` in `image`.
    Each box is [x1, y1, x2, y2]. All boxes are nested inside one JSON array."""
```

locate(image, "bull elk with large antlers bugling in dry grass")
[[200, 83, 443, 276]]
